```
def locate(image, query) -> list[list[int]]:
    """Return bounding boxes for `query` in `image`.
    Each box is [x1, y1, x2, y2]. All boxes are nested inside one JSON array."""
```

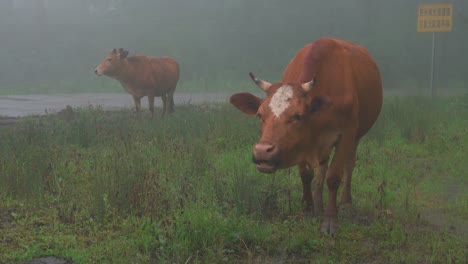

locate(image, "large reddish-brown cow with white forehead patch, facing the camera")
[[230, 38, 382, 234]]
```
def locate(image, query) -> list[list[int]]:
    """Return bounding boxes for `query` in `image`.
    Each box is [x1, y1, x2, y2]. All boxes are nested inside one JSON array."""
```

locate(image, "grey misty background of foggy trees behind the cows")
[[0, 0, 468, 94]]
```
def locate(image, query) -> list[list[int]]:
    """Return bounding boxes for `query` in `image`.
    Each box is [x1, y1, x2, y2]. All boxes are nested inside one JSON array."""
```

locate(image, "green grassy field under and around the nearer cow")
[[0, 96, 468, 263]]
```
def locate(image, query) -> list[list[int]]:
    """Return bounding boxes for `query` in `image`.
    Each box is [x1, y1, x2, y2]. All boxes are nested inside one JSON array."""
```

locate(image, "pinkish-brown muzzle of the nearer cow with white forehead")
[[252, 142, 279, 173]]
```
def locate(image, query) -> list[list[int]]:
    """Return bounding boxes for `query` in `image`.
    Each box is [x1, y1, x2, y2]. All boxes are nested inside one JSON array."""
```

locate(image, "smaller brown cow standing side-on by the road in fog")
[[94, 49, 179, 117]]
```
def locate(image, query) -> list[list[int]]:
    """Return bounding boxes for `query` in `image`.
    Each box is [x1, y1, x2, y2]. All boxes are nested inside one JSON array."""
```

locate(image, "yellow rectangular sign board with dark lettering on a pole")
[[417, 3, 453, 32]]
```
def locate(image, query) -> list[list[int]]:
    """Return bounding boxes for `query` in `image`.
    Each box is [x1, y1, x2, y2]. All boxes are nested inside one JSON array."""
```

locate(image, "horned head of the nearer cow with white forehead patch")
[[230, 73, 330, 173]]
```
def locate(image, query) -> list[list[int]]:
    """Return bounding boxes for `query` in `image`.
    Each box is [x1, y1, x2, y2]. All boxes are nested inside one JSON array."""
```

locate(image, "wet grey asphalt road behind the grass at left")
[[0, 93, 229, 117]]
